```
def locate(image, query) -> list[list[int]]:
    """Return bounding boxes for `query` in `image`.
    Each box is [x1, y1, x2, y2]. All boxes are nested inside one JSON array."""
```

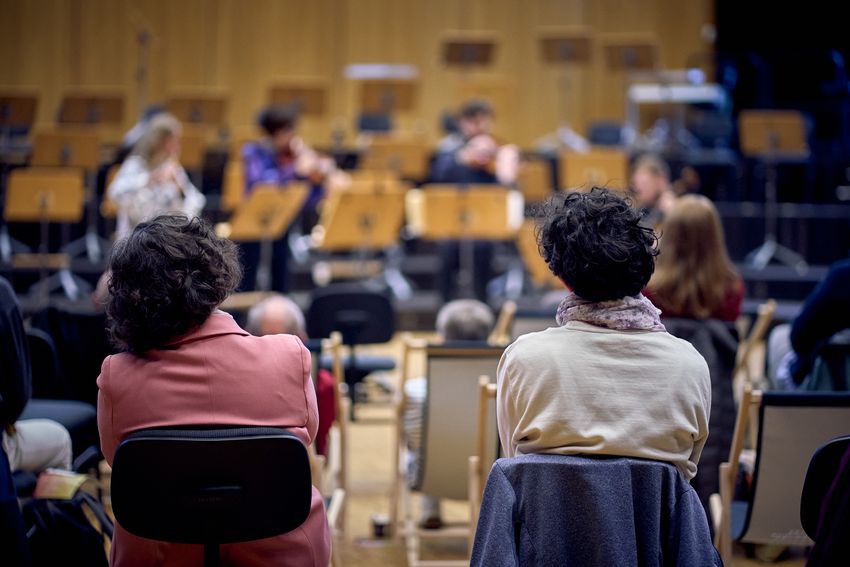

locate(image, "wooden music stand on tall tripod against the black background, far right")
[[738, 110, 809, 273]]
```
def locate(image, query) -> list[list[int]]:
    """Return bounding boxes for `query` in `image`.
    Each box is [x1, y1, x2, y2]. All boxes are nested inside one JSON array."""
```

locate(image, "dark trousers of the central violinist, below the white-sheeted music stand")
[[438, 240, 493, 302]]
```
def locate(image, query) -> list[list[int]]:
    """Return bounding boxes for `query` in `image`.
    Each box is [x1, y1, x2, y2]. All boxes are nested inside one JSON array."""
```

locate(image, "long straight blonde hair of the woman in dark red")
[[649, 195, 738, 319]]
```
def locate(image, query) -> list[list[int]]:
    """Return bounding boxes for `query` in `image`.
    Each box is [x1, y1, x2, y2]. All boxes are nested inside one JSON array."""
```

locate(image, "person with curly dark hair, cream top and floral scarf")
[[496, 188, 711, 479]]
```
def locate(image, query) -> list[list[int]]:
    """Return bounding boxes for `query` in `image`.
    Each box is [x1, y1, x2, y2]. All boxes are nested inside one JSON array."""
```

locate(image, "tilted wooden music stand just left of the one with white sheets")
[[312, 183, 412, 299]]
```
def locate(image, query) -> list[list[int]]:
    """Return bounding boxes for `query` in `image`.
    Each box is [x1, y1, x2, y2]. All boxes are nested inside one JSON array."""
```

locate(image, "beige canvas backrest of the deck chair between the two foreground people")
[[415, 341, 504, 500]]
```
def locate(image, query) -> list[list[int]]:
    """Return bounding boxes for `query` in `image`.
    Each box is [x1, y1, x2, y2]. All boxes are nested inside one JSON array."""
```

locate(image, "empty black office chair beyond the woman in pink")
[[307, 282, 395, 419]]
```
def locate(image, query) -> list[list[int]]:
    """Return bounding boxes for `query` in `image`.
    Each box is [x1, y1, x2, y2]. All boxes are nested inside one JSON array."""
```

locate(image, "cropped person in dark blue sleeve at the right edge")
[[767, 260, 850, 390]]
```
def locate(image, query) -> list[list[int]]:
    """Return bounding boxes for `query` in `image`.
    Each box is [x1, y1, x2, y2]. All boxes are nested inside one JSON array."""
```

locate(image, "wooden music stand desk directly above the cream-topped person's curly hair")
[[558, 149, 629, 191]]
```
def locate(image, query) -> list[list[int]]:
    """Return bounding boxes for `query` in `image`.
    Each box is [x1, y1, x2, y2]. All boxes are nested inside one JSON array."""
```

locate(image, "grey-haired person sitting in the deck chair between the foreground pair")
[[404, 299, 495, 529]]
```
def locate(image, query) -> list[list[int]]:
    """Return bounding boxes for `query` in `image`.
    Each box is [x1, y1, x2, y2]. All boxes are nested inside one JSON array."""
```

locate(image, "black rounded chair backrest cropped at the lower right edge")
[[800, 435, 850, 540]]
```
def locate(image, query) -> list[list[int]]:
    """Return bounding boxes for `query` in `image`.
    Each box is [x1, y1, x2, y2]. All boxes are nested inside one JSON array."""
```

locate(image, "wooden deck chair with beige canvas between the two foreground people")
[[390, 340, 504, 567]]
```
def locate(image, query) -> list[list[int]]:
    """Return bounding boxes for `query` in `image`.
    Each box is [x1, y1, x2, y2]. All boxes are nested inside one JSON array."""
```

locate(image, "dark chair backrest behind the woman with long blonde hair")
[[664, 318, 738, 510]]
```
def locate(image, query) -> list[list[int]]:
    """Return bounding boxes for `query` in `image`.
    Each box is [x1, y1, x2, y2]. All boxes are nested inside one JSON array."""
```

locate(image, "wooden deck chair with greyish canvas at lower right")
[[711, 385, 850, 566]]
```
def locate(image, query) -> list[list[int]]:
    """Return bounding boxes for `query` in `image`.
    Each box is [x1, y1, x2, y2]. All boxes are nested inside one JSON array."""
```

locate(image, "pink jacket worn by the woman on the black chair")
[[97, 311, 331, 567]]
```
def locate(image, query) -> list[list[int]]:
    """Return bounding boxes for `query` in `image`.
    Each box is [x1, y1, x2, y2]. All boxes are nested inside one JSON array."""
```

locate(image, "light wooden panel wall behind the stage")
[[0, 0, 713, 146]]
